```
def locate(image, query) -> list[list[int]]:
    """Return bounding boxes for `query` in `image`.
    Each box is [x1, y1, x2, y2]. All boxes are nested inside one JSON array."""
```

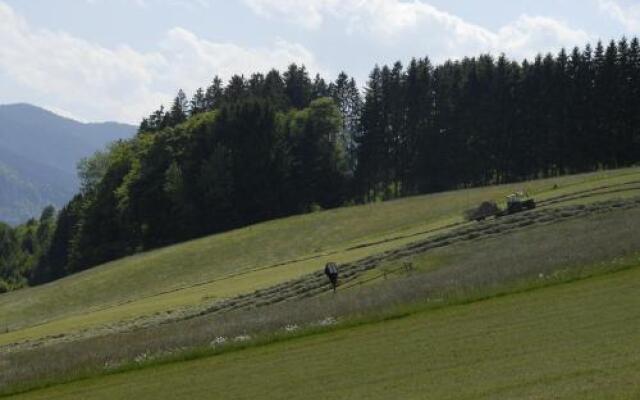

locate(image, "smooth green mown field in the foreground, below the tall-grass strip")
[[15, 265, 640, 400]]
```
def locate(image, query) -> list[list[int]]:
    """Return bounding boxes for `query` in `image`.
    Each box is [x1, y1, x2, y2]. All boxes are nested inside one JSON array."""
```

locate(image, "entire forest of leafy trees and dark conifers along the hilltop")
[[0, 38, 640, 287]]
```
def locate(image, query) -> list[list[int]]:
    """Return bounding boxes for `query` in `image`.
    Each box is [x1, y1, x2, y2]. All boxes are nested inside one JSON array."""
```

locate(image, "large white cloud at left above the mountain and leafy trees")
[[0, 1, 319, 122]]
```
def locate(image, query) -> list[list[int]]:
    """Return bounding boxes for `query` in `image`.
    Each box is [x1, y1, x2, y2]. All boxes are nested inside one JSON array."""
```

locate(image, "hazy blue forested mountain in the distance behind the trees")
[[0, 104, 136, 224]]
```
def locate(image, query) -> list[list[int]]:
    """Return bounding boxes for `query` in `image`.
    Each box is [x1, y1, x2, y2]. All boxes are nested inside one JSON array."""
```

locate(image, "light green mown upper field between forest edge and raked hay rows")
[[0, 168, 640, 345]]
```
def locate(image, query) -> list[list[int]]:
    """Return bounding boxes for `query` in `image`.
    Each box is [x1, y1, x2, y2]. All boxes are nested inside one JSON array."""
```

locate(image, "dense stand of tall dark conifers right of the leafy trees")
[[356, 38, 640, 200]]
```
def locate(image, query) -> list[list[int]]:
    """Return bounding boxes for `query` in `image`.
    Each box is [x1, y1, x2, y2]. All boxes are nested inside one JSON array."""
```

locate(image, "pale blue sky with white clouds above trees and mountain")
[[0, 0, 640, 124]]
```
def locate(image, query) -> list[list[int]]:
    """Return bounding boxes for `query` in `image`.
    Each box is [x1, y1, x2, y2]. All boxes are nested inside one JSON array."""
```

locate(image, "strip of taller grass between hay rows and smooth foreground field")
[[0, 202, 640, 394]]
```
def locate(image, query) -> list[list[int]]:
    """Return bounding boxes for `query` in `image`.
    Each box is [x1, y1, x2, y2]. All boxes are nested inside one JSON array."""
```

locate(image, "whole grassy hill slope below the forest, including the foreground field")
[[0, 168, 640, 398]]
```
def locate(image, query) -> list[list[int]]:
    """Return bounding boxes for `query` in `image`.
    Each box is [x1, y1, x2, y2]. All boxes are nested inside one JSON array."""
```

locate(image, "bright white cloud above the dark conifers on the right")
[[244, 0, 590, 60]]
